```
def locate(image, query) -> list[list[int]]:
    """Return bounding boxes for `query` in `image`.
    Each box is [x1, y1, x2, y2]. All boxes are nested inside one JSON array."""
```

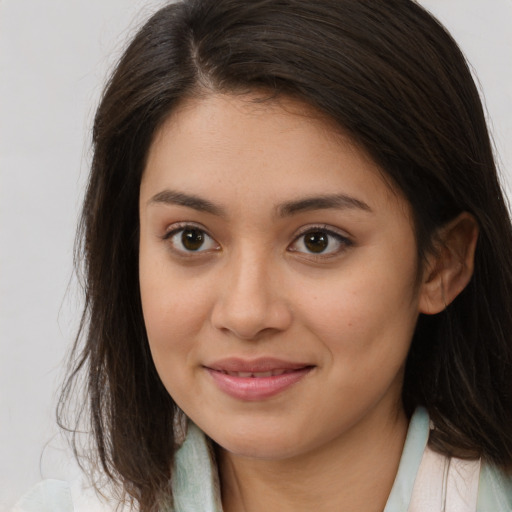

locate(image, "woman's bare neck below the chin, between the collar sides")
[[218, 408, 407, 512]]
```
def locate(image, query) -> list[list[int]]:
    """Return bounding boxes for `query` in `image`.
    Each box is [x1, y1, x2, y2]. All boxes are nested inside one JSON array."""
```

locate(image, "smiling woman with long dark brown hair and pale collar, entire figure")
[[11, 0, 512, 512]]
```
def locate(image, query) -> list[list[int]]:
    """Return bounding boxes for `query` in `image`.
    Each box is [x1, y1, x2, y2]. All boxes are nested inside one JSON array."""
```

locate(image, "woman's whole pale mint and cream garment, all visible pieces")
[[11, 408, 512, 512]]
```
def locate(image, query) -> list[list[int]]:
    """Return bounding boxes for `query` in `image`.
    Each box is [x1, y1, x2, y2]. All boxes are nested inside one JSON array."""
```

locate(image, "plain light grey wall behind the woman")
[[0, 0, 512, 510]]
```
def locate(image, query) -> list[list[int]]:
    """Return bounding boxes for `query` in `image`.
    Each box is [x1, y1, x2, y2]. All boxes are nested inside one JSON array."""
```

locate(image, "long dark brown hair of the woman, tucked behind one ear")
[[60, 0, 512, 511]]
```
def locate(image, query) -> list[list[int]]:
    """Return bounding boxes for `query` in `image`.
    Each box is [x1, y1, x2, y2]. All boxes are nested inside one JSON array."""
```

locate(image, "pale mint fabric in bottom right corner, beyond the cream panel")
[[477, 463, 512, 512]]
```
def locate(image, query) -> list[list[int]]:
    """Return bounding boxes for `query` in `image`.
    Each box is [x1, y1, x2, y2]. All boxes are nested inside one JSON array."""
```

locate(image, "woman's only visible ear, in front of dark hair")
[[419, 212, 478, 315]]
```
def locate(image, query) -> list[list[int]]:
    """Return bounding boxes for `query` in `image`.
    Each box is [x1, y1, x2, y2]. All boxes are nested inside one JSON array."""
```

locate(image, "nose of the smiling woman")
[[211, 249, 292, 340]]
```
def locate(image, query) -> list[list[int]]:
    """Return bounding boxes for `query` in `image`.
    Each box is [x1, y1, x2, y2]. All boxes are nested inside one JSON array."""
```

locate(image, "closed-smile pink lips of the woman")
[[204, 358, 314, 401]]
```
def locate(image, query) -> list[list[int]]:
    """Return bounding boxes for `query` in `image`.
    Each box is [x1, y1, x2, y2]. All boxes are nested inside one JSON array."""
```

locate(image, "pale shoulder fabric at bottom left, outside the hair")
[[11, 477, 129, 512]]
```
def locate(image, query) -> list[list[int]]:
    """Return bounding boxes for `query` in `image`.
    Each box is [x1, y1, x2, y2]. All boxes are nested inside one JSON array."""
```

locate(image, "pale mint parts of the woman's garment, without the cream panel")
[[12, 408, 512, 512]]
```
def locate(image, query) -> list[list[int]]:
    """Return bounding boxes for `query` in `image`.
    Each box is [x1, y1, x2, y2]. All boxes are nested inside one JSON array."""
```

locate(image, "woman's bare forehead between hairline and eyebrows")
[[141, 94, 403, 217]]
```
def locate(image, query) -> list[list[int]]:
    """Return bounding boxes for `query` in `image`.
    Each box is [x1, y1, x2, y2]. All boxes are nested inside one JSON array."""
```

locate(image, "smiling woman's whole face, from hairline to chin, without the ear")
[[140, 95, 421, 458]]
